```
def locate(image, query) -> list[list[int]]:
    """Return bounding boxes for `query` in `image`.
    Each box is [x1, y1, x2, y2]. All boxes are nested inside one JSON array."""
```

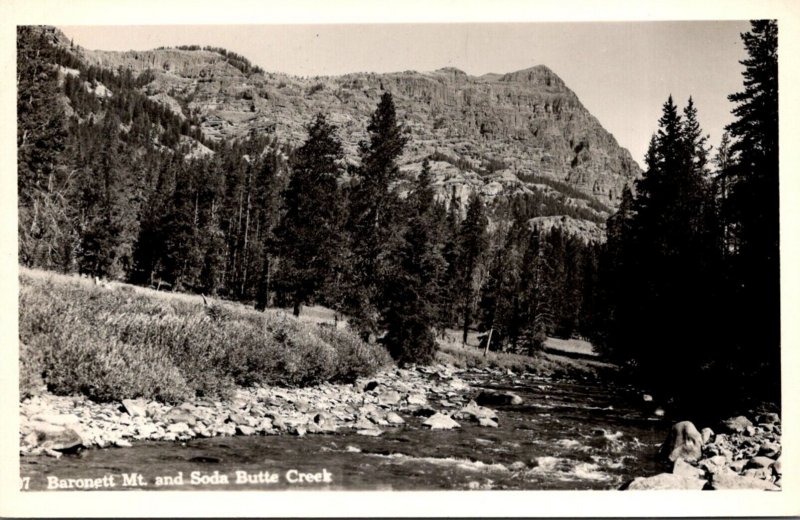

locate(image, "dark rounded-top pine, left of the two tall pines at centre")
[[276, 114, 343, 316]]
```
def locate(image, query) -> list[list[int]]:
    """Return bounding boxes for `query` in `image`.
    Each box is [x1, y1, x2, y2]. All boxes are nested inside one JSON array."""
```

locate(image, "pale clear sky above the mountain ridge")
[[60, 21, 749, 164]]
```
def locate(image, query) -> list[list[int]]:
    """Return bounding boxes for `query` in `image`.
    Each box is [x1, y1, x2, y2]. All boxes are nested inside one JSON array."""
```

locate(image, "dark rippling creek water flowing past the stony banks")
[[21, 375, 669, 490]]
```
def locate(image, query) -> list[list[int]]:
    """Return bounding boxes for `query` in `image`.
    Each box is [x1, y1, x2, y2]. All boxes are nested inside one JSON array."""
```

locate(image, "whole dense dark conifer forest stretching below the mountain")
[[17, 21, 780, 416]]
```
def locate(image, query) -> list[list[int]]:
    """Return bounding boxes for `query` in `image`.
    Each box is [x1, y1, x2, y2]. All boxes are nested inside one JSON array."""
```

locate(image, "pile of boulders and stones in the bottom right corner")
[[624, 413, 783, 491]]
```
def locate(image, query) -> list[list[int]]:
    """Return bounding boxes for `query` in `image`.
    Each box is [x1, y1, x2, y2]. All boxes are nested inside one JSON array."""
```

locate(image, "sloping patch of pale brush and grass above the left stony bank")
[[19, 268, 391, 402]]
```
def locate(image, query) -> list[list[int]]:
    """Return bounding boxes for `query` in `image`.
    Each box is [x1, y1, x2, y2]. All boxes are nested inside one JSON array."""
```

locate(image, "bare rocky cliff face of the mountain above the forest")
[[79, 43, 640, 207]]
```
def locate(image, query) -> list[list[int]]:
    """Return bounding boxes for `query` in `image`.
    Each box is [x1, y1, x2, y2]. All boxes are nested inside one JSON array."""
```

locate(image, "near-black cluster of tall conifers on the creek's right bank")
[[595, 20, 780, 416]]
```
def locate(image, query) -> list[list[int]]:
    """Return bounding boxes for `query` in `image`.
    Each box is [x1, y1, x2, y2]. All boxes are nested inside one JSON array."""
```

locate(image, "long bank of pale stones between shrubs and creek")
[[20, 365, 521, 457]]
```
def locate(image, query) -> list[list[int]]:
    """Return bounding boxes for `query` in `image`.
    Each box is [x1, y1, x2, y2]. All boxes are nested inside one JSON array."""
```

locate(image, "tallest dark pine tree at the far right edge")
[[723, 20, 780, 397]]
